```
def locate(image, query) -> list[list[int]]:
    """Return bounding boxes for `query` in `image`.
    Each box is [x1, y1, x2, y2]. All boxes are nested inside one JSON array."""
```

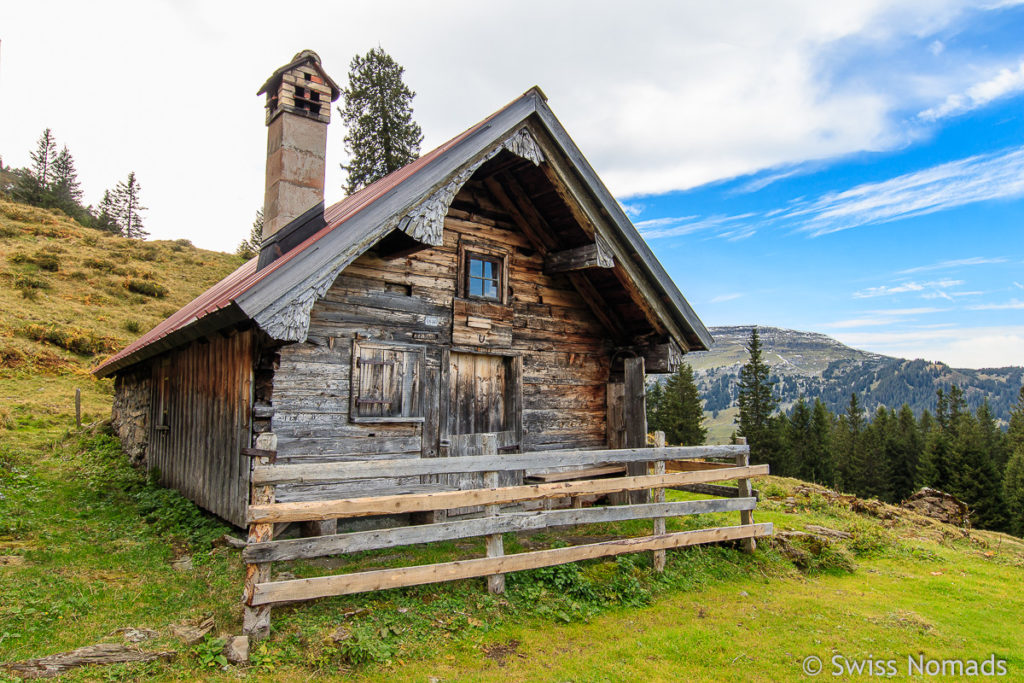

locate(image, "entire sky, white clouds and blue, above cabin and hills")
[[0, 0, 1024, 368]]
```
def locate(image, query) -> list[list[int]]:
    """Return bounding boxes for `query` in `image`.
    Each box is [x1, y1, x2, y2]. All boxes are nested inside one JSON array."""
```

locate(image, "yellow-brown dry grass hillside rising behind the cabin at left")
[[0, 200, 241, 444]]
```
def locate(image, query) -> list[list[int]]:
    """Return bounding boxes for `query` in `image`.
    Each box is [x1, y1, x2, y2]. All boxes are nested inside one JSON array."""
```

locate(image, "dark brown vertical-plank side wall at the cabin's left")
[[146, 331, 253, 526]]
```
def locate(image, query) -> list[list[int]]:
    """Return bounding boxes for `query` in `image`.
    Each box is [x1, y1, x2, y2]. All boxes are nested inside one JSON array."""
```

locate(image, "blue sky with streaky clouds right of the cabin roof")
[[622, 7, 1024, 367]]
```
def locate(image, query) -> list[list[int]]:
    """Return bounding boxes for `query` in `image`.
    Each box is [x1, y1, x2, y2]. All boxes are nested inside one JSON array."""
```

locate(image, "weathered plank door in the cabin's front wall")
[[446, 352, 522, 514]]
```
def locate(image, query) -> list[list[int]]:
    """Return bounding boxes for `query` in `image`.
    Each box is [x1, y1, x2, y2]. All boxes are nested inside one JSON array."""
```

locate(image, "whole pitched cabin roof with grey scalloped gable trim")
[[94, 87, 712, 376]]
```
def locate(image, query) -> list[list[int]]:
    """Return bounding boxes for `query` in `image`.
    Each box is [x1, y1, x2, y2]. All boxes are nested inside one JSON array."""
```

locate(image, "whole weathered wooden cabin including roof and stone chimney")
[[95, 51, 712, 526]]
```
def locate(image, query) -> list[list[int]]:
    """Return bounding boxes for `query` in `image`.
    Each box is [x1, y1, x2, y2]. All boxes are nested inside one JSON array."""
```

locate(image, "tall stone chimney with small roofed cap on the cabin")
[[256, 50, 341, 240]]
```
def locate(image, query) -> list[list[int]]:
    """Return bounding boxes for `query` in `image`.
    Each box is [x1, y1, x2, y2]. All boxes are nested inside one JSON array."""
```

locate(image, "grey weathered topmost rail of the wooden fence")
[[252, 445, 748, 483]]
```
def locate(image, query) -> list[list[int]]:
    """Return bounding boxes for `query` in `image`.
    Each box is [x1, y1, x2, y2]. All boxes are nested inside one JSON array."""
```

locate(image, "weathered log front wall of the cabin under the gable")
[[272, 180, 611, 502]]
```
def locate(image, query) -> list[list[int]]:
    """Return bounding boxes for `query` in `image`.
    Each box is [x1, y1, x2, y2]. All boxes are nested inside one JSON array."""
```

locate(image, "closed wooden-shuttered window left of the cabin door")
[[349, 341, 423, 422]]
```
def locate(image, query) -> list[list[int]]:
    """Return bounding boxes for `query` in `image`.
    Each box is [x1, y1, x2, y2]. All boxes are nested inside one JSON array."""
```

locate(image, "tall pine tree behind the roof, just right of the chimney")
[[338, 47, 423, 194]]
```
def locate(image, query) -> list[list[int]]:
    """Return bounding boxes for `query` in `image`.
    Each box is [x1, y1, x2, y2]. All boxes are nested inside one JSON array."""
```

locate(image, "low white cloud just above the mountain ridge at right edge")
[[836, 325, 1024, 368]]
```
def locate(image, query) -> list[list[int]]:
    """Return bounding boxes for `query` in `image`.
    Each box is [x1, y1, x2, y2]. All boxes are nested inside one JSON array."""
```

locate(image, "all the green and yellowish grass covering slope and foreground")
[[0, 197, 1024, 683]]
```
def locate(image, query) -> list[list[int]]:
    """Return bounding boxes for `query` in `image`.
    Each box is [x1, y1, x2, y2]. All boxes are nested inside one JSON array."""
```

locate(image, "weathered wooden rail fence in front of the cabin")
[[237, 433, 772, 637]]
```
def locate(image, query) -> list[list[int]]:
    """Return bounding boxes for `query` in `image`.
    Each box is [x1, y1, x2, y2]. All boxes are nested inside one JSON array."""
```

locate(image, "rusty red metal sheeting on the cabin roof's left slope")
[[92, 93, 518, 377]]
